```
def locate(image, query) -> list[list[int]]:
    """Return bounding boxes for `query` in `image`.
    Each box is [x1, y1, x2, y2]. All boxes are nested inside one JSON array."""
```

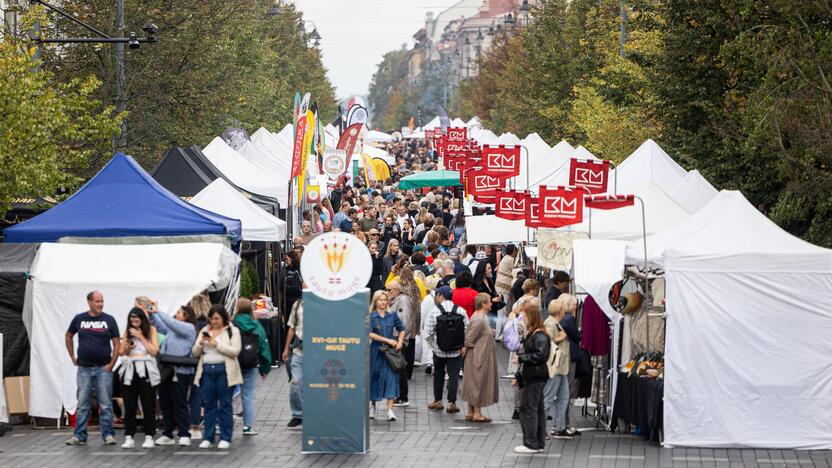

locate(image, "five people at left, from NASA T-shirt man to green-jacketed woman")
[[66, 291, 272, 449]]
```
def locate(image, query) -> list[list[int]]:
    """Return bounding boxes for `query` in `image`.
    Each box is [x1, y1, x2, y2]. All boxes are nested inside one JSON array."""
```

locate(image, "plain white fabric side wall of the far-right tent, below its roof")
[[664, 269, 832, 449]]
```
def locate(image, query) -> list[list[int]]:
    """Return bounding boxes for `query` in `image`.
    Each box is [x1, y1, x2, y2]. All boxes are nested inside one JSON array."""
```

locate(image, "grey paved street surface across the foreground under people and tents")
[[0, 352, 832, 468]]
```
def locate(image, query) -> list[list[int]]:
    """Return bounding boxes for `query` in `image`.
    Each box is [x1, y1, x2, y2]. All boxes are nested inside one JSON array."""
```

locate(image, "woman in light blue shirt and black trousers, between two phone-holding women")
[[148, 303, 202, 447]]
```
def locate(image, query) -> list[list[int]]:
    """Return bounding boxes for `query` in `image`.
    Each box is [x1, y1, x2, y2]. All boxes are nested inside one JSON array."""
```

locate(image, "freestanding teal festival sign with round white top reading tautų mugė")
[[300, 232, 372, 453]]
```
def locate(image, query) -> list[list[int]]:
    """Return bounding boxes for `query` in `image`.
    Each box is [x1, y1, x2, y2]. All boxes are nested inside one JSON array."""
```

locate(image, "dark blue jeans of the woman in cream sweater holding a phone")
[[204, 364, 234, 443]]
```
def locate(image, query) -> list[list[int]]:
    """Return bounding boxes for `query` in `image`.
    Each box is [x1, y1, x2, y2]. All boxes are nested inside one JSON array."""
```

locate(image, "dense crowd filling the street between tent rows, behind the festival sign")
[[283, 136, 580, 453]]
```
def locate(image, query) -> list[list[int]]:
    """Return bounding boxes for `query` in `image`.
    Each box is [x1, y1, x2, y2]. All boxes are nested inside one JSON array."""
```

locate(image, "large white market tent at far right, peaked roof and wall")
[[648, 192, 832, 449]]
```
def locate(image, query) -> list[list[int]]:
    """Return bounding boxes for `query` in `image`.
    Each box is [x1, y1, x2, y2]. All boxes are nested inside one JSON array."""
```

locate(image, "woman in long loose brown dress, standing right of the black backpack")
[[462, 293, 500, 422]]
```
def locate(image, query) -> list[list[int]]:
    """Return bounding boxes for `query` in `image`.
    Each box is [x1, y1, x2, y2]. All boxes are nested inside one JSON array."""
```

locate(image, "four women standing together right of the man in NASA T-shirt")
[[117, 294, 271, 449]]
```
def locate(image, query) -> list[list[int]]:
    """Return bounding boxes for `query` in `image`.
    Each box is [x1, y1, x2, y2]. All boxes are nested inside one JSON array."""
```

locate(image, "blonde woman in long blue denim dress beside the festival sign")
[[370, 291, 404, 421]]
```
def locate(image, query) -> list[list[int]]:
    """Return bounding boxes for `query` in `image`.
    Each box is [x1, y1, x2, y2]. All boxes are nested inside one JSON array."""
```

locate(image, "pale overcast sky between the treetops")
[[294, 0, 459, 98]]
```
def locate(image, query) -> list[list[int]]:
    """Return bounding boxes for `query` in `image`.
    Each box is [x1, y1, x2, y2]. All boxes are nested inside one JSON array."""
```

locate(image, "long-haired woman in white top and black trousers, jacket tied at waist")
[[117, 307, 161, 449]]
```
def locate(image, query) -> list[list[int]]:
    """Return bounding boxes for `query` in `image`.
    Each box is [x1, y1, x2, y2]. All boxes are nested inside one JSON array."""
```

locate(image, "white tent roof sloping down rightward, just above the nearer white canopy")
[[202, 137, 289, 207]]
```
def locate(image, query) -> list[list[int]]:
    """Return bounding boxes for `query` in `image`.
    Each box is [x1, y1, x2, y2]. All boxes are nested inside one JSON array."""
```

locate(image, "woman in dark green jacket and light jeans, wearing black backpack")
[[234, 297, 272, 436]]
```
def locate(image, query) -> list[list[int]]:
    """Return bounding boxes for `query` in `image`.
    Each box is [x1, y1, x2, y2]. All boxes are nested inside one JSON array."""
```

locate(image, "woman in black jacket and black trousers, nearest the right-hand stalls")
[[514, 301, 551, 453]]
